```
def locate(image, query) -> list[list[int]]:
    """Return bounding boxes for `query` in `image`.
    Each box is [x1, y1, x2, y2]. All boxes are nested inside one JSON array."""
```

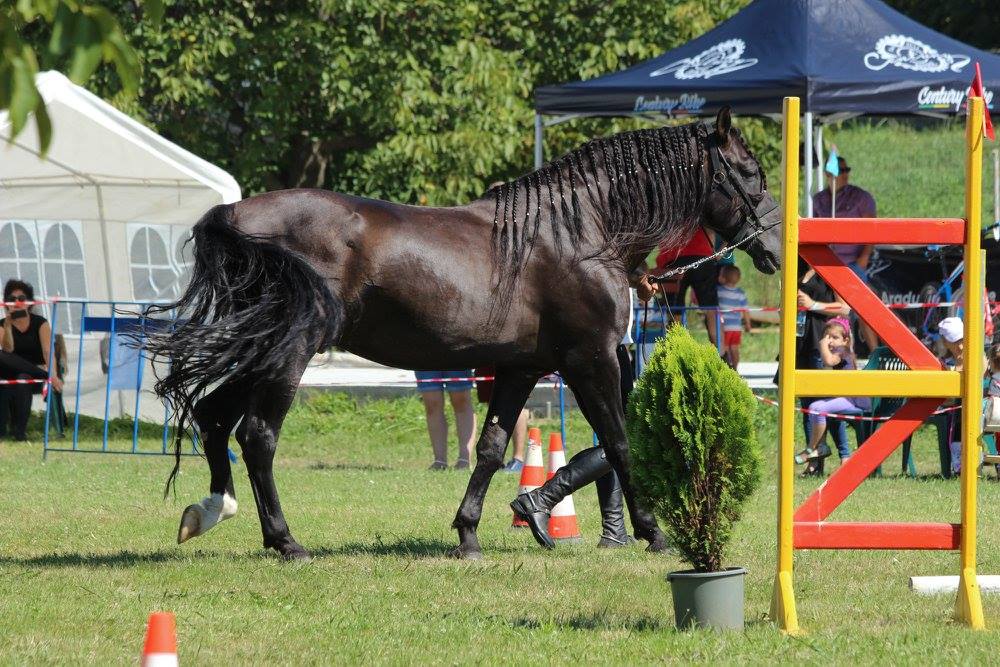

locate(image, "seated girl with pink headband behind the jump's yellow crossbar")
[[795, 317, 871, 476]]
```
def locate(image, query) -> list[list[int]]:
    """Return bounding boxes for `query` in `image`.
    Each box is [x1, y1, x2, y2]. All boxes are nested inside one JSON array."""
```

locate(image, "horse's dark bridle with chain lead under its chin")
[[649, 131, 781, 283]]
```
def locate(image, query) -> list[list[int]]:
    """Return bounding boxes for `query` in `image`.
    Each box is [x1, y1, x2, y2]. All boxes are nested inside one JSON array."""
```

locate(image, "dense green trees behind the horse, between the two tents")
[[66, 0, 747, 205]]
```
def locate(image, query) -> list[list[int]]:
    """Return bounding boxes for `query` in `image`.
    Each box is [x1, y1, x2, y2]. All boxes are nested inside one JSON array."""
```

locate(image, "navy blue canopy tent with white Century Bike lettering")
[[535, 0, 1000, 215]]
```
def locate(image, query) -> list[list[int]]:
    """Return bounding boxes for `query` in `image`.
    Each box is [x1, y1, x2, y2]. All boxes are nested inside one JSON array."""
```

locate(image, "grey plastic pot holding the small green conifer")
[[667, 567, 747, 630]]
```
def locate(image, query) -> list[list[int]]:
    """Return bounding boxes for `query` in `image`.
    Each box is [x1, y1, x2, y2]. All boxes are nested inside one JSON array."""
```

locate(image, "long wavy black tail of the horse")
[[143, 204, 343, 491]]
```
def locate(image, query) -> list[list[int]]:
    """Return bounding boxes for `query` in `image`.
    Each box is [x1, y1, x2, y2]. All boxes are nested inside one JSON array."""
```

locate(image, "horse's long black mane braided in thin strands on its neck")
[[487, 122, 724, 323]]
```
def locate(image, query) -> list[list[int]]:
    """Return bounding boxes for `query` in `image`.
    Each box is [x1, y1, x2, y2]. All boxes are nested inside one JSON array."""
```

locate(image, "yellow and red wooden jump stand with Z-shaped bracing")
[[771, 97, 984, 633]]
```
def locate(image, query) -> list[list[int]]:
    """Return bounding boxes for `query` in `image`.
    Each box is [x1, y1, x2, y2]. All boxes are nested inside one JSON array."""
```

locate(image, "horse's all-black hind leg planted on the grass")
[[236, 355, 309, 559]]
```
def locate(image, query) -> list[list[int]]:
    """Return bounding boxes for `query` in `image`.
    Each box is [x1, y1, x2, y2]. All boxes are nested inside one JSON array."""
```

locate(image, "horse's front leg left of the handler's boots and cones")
[[451, 367, 541, 560]]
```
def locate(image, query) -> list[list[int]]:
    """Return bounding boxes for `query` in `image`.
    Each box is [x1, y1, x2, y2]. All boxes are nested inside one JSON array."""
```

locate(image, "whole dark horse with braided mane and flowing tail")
[[146, 109, 780, 558]]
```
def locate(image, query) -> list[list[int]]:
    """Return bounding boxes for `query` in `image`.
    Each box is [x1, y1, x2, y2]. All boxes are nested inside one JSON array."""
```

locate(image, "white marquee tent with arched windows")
[[0, 72, 240, 333]]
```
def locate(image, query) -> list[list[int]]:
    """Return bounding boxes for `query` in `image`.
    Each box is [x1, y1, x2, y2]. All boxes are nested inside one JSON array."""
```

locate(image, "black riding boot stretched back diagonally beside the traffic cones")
[[510, 447, 611, 549]]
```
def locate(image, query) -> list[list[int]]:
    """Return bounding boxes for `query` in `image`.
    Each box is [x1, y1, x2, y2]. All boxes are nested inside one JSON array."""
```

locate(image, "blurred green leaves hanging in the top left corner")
[[0, 0, 163, 152]]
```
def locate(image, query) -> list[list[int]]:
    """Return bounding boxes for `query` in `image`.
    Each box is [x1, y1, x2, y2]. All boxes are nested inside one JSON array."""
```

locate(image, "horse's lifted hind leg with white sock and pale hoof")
[[177, 384, 246, 544]]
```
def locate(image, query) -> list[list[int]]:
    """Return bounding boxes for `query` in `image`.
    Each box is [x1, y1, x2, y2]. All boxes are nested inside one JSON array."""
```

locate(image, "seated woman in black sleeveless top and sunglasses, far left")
[[0, 279, 62, 441]]
